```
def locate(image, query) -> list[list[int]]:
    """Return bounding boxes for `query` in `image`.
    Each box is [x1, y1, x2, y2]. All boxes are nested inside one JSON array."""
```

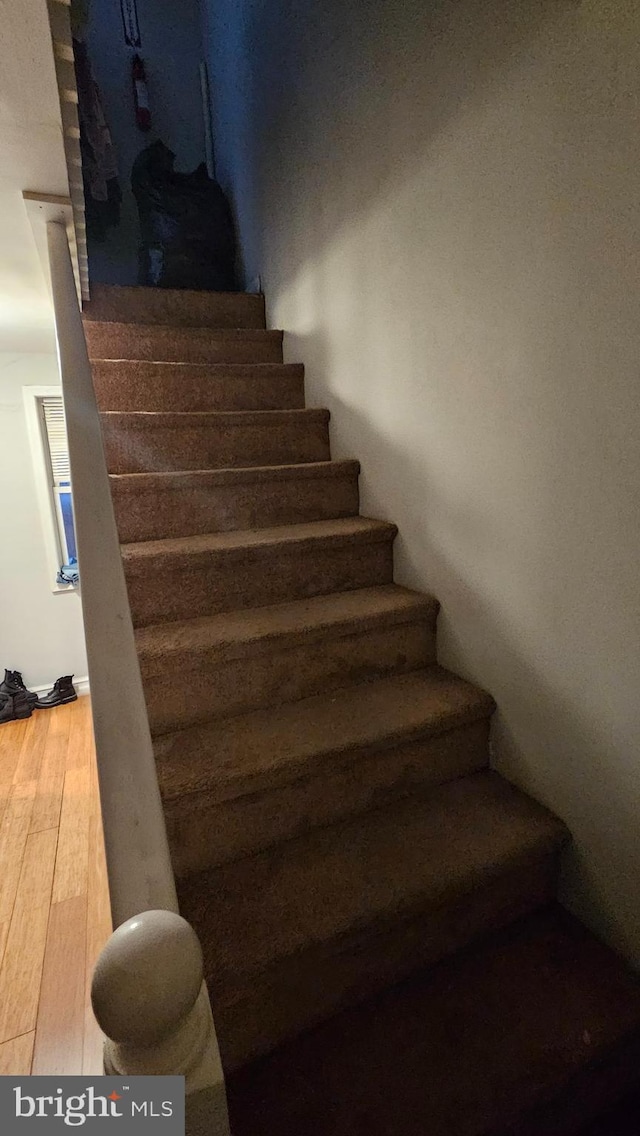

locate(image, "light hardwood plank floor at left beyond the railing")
[[0, 698, 111, 1075]]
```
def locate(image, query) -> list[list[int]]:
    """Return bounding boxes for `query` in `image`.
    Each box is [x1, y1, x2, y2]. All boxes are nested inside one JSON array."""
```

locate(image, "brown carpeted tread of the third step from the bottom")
[[155, 667, 494, 801]]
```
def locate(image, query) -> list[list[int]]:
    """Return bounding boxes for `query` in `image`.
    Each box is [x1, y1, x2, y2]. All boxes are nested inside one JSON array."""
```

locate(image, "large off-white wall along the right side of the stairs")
[[203, 0, 640, 962]]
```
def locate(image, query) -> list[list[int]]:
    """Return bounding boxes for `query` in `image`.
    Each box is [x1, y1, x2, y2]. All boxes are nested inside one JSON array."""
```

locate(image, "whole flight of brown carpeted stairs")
[[84, 285, 640, 1136]]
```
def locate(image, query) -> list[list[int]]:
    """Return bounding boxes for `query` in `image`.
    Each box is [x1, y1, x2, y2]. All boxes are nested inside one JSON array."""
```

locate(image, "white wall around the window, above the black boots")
[[0, 352, 86, 687]]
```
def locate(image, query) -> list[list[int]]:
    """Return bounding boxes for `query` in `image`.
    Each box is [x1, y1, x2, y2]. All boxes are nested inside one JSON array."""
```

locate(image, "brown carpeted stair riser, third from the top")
[[92, 359, 305, 411]]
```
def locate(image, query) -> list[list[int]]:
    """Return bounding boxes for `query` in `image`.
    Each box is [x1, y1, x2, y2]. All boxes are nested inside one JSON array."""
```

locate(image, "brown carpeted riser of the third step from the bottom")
[[163, 718, 489, 876]]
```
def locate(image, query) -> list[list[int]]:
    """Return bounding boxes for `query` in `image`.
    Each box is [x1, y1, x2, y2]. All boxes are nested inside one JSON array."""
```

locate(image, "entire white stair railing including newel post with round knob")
[[47, 214, 228, 1136]]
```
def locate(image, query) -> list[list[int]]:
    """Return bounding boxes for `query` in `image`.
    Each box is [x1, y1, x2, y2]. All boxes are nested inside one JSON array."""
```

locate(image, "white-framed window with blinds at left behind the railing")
[[23, 386, 77, 592]]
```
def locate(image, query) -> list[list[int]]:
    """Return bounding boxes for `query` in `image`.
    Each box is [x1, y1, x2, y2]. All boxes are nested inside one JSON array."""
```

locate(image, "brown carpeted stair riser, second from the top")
[[84, 320, 282, 364]]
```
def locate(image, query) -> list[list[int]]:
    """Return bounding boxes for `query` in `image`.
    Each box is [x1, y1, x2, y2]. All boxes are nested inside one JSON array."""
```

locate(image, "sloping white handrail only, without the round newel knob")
[[47, 222, 177, 927]]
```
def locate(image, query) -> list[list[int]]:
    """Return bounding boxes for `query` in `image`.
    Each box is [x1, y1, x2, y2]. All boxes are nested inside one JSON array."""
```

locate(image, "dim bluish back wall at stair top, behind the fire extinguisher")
[[85, 0, 205, 284]]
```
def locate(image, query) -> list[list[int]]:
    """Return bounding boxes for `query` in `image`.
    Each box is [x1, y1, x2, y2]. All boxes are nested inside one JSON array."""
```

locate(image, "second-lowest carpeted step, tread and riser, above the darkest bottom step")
[[178, 774, 566, 1069]]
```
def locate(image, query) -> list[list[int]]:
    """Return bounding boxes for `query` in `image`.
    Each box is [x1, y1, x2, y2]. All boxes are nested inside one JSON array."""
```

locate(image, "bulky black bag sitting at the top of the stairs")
[[131, 141, 235, 292]]
